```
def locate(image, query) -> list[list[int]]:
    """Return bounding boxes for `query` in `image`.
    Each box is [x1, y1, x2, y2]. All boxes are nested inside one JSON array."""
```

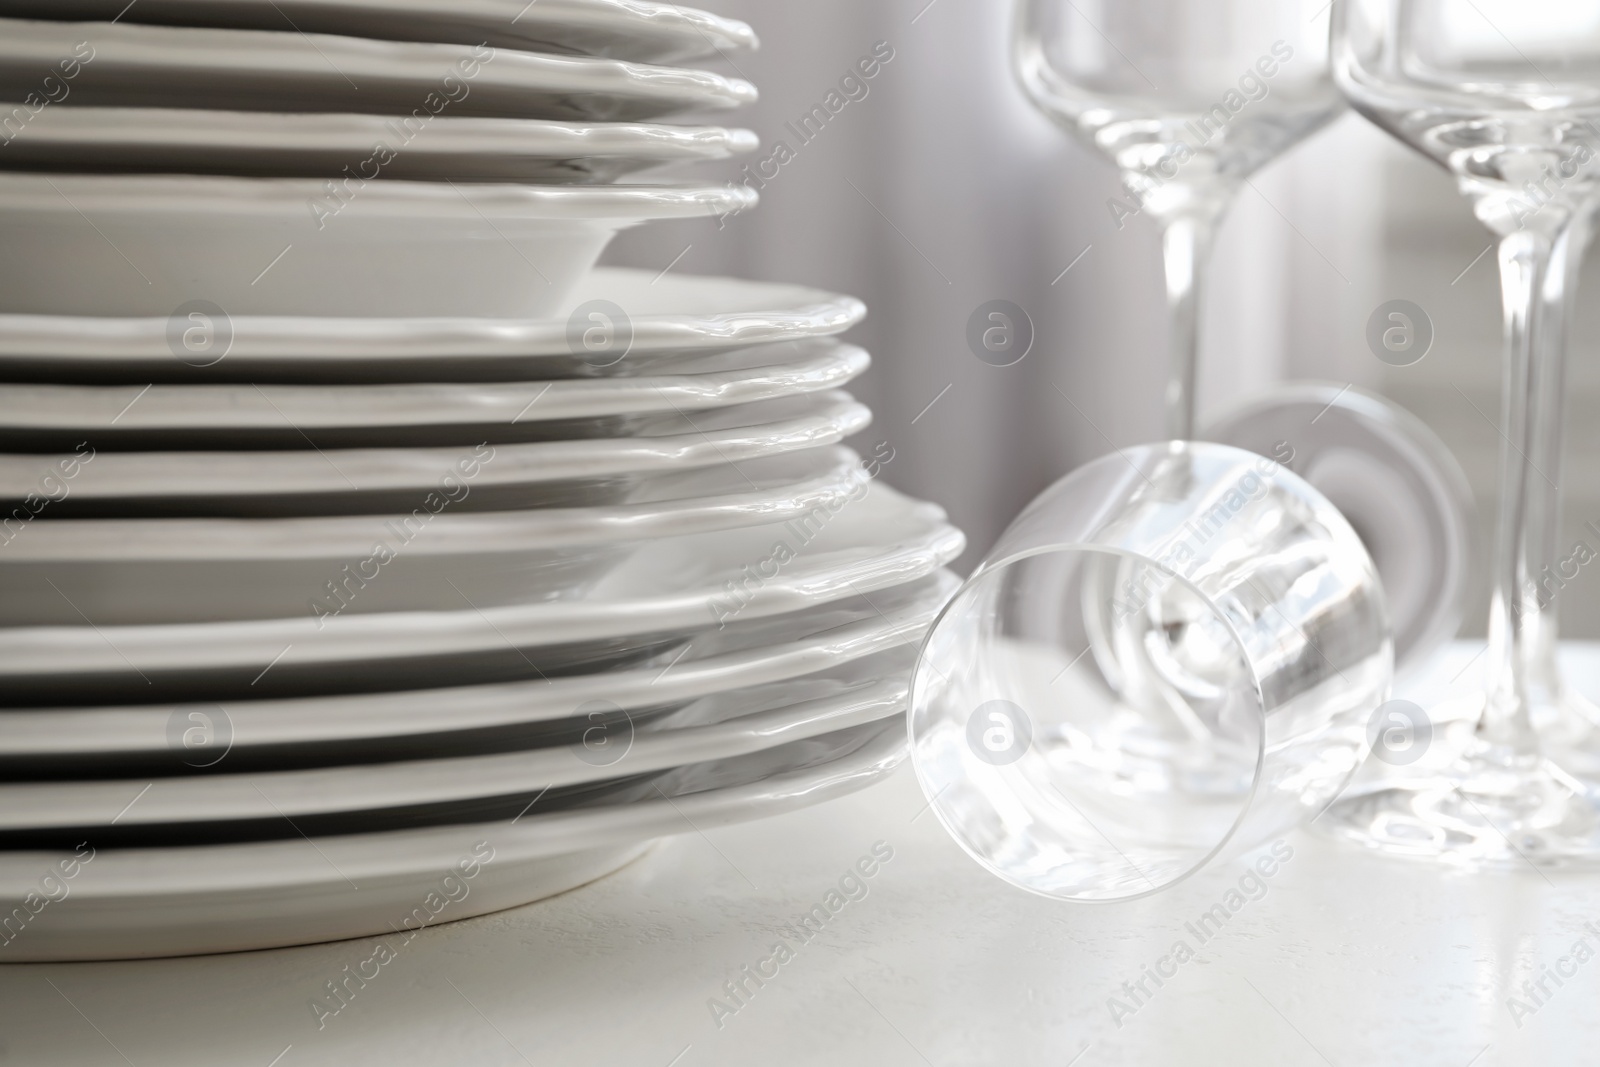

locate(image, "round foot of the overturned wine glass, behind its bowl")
[[1205, 382, 1474, 669]]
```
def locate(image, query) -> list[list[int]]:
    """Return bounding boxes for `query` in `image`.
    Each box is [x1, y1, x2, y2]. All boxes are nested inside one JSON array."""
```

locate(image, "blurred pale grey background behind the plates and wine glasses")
[[606, 0, 1600, 638]]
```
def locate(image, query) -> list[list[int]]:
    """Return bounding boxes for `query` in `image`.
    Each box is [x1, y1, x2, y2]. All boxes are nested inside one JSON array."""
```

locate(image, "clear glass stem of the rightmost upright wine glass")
[[1478, 216, 1586, 755]]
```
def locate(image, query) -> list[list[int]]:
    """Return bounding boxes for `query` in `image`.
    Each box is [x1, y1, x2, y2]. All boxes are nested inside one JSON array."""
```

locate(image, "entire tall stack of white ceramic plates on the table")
[[0, 0, 962, 961]]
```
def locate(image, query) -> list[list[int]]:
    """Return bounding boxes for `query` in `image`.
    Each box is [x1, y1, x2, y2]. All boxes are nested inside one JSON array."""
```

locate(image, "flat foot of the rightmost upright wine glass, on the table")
[[1314, 741, 1600, 870]]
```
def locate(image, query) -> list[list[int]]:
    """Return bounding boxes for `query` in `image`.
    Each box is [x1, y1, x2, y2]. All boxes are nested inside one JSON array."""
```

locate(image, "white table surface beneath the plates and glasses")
[[0, 646, 1600, 1067]]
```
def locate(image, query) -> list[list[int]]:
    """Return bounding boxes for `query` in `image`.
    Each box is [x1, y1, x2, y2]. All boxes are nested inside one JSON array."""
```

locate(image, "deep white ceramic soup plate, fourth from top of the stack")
[[0, 173, 755, 316]]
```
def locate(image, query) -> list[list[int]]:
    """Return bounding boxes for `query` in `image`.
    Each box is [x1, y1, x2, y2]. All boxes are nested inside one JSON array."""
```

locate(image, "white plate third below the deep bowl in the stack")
[[0, 392, 872, 518]]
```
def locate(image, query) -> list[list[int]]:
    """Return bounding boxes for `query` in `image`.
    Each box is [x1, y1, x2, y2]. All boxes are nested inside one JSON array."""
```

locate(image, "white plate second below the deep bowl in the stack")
[[0, 338, 872, 451]]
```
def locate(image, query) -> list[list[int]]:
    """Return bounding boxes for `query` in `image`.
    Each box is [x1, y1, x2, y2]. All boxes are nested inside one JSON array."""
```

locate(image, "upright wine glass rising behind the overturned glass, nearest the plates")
[[1013, 0, 1344, 440]]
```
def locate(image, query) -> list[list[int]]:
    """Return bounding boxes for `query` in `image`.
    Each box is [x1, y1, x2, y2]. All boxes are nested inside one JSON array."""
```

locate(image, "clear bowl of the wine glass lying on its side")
[[907, 442, 1394, 901]]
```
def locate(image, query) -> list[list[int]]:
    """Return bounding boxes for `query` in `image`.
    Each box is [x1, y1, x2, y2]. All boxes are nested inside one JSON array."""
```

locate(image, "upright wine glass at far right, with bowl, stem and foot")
[[1318, 0, 1600, 867]]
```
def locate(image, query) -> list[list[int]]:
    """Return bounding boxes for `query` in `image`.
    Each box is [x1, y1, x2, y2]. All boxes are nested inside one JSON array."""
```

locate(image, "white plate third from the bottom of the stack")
[[0, 571, 960, 767]]
